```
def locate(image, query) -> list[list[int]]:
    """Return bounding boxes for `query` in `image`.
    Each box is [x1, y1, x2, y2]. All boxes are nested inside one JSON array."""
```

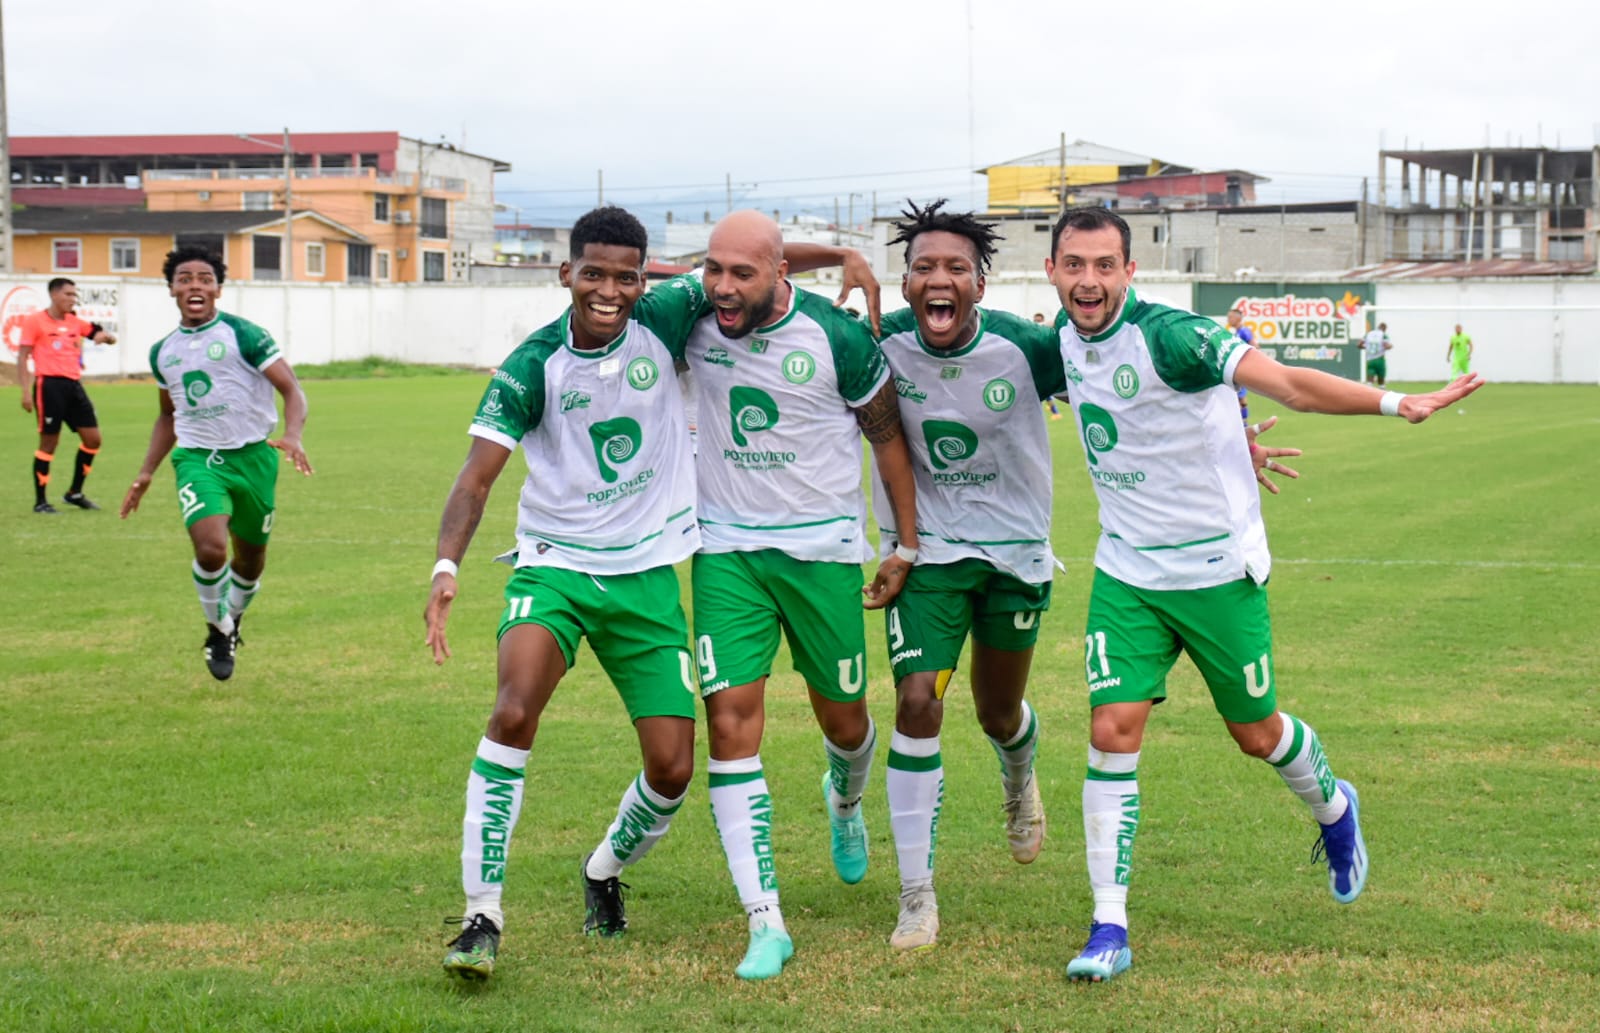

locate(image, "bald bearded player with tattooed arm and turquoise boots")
[[688, 211, 917, 979]]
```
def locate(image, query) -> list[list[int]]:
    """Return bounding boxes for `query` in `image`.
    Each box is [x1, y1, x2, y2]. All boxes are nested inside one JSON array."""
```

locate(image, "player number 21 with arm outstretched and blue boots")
[[1045, 208, 1482, 982]]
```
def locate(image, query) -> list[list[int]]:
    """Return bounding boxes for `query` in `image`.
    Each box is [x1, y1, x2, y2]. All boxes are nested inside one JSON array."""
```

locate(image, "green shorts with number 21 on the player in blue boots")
[[1083, 569, 1278, 724]]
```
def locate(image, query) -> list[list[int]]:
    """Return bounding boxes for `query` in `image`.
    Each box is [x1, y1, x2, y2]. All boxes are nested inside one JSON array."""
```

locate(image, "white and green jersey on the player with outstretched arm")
[[1058, 288, 1272, 590]]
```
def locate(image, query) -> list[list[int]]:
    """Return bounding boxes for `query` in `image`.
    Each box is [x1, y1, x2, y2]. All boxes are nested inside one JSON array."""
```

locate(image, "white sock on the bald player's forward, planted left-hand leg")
[[706, 753, 784, 932]]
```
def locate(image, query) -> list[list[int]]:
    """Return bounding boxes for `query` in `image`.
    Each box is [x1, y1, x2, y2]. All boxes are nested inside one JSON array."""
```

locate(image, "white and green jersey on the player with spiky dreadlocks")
[[872, 309, 1066, 584]]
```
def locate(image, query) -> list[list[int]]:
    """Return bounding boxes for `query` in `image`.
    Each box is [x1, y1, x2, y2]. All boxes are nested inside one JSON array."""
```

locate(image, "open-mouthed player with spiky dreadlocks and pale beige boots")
[[875, 200, 1066, 950]]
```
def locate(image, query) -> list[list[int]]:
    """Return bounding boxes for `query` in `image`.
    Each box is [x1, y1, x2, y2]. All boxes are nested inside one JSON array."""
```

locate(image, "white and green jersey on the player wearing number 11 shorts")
[[469, 277, 706, 574]]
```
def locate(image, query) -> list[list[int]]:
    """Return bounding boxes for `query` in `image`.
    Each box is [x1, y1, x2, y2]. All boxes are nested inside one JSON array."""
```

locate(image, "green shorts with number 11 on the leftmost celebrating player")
[[499, 566, 694, 721]]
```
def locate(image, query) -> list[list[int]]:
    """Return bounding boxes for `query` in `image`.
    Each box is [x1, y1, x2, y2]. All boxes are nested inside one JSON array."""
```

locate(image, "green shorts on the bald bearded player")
[[693, 548, 867, 704]]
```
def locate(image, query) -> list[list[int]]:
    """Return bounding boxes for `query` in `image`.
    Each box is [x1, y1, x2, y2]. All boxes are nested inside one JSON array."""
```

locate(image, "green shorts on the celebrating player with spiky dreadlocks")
[[883, 558, 1050, 684]]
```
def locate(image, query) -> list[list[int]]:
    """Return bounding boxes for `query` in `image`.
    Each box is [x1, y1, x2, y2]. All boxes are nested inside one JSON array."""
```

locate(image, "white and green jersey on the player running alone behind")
[[150, 312, 283, 448]]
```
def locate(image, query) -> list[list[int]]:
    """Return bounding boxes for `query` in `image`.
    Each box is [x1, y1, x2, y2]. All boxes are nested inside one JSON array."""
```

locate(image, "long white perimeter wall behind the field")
[[12, 275, 1600, 384]]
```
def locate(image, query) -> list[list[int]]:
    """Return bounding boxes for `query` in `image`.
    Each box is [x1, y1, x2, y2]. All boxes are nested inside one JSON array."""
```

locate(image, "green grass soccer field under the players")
[[0, 376, 1600, 1033]]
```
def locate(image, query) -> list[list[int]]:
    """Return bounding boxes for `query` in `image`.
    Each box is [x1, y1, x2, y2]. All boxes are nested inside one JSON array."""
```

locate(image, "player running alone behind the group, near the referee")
[[122, 245, 312, 681]]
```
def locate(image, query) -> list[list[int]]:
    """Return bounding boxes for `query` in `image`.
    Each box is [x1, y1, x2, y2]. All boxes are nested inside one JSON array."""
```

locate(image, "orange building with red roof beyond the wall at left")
[[11, 133, 510, 283]]
